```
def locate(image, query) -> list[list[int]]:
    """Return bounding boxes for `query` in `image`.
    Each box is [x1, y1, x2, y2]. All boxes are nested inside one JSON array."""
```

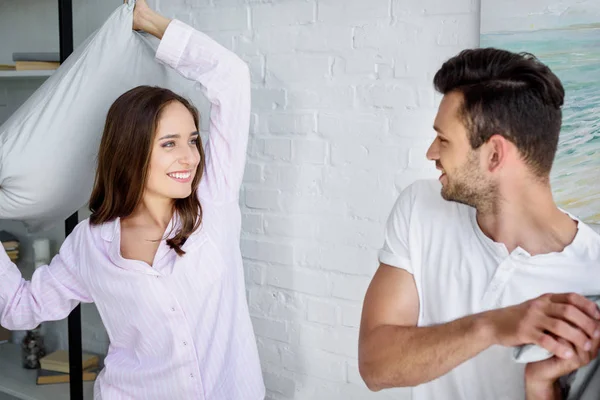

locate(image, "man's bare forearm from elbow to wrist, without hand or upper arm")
[[360, 314, 494, 390]]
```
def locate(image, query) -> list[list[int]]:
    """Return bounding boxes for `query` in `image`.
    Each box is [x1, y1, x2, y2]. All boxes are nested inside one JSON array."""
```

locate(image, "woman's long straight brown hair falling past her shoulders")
[[89, 86, 204, 256]]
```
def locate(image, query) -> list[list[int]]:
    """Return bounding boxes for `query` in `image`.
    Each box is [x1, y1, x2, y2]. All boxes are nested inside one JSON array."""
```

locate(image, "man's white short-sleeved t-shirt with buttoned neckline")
[[379, 180, 600, 400]]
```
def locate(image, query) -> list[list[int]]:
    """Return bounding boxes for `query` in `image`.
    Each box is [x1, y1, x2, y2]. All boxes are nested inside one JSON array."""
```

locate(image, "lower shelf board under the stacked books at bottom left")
[[0, 343, 94, 400]]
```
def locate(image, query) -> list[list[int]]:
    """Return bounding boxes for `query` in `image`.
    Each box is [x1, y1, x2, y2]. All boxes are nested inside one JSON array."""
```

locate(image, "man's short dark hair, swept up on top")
[[433, 48, 565, 178]]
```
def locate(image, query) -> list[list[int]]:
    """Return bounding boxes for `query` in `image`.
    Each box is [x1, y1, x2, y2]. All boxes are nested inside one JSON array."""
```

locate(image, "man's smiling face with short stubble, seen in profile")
[[427, 92, 495, 207]]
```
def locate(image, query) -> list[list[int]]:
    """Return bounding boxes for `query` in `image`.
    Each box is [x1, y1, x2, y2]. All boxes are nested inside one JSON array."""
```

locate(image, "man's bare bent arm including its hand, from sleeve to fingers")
[[359, 264, 600, 392]]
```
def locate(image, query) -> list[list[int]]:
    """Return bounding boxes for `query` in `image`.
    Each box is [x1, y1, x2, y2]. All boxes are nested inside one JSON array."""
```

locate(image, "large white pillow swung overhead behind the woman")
[[0, 1, 203, 231]]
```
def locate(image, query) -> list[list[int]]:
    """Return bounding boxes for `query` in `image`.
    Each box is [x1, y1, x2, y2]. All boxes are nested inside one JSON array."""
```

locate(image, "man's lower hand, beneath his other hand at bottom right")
[[525, 339, 600, 400]]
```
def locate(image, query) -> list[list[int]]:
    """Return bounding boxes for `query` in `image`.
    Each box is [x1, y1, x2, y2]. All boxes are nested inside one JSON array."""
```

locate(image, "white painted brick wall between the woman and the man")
[[158, 0, 479, 400]]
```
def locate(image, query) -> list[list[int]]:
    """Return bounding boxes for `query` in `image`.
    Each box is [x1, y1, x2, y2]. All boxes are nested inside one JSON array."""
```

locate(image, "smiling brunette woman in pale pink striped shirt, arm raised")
[[0, 0, 265, 400]]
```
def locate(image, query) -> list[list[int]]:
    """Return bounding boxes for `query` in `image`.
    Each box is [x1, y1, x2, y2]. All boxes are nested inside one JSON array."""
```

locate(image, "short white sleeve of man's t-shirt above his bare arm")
[[379, 184, 414, 274]]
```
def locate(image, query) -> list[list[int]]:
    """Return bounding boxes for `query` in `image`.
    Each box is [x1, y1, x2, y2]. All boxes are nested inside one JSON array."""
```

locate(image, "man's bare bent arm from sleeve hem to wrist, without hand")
[[359, 264, 493, 391]]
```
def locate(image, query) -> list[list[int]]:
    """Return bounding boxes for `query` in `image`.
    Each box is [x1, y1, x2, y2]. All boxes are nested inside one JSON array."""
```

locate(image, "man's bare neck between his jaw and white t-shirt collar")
[[477, 184, 577, 255]]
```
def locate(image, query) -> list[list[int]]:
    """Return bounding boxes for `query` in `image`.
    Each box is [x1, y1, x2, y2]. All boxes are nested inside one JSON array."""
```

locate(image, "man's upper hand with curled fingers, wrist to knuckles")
[[485, 293, 600, 362]]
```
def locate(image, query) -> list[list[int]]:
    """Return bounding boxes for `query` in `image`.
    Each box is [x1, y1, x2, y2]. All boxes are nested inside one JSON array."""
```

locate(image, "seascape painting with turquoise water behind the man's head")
[[480, 0, 600, 223]]
